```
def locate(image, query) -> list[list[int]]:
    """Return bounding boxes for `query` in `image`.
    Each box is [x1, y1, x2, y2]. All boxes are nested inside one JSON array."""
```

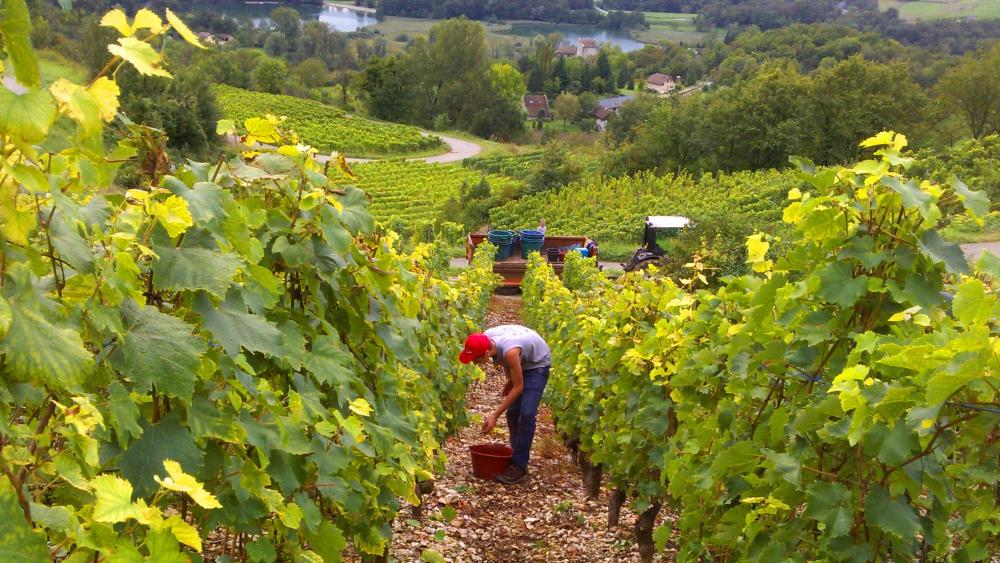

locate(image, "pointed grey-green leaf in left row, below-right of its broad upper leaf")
[[193, 291, 284, 357]]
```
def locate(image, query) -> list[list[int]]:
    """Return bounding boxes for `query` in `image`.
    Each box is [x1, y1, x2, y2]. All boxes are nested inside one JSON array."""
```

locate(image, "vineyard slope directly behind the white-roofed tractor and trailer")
[[490, 172, 799, 242]]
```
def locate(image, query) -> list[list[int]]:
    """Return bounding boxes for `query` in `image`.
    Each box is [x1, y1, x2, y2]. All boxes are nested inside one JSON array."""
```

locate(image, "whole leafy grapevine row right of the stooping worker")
[[524, 133, 1000, 561]]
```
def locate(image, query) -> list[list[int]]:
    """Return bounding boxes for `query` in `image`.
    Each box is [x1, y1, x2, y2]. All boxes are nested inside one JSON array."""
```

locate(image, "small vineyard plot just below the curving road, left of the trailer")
[[333, 160, 516, 228]]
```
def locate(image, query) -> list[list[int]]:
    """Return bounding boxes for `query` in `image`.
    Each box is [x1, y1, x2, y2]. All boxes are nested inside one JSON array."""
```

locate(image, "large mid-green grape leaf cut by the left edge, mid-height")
[[0, 300, 94, 389]]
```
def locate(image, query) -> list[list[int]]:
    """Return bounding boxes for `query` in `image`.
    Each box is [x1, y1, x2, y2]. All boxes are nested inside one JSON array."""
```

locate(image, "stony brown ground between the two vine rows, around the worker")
[[364, 296, 673, 563]]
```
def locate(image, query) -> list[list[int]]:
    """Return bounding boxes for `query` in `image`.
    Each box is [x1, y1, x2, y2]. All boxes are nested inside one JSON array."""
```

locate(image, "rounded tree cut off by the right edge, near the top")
[[939, 45, 1000, 139]]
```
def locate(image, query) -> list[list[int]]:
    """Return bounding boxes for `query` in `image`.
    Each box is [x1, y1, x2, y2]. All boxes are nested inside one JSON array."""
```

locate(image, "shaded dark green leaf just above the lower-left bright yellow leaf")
[[118, 411, 204, 498]]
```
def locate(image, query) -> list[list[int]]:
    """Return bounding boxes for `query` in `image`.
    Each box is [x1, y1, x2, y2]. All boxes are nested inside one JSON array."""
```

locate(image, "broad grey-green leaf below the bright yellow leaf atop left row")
[[153, 244, 241, 297]]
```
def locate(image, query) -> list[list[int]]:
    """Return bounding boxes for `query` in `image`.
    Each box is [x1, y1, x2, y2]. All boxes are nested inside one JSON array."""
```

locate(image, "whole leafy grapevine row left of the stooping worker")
[[0, 5, 496, 561]]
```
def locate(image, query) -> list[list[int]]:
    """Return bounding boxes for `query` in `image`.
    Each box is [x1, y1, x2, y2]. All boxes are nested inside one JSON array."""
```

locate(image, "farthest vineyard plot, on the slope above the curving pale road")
[[212, 84, 441, 156]]
